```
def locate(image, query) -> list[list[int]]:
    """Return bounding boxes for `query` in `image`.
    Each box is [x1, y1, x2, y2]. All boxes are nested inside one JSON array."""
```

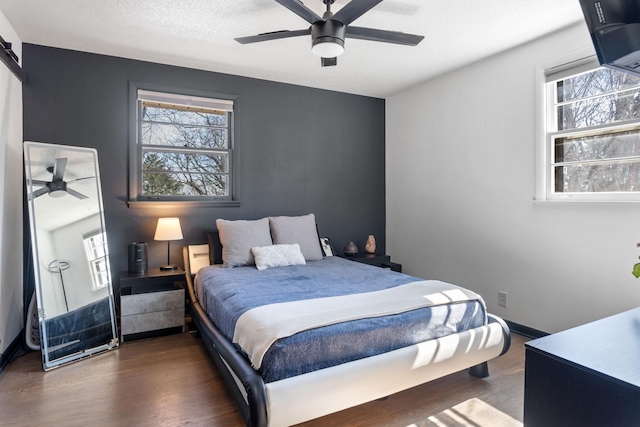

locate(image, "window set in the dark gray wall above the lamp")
[[130, 88, 234, 206]]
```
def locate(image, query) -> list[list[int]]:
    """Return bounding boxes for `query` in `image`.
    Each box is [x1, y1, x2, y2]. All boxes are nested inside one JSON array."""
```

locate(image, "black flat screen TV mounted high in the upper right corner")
[[580, 0, 640, 75]]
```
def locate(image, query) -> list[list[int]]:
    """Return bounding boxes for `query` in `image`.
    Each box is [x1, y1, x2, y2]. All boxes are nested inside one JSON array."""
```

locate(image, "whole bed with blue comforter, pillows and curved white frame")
[[184, 214, 510, 427]]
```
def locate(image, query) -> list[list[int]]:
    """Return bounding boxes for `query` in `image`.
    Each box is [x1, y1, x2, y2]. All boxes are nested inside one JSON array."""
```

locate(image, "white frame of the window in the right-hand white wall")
[[535, 53, 640, 202]]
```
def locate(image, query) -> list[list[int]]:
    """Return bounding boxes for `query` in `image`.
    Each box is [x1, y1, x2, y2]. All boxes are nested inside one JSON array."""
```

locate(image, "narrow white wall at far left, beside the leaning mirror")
[[0, 12, 23, 353]]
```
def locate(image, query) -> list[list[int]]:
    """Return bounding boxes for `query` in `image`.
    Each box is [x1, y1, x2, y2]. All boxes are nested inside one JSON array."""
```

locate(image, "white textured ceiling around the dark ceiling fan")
[[0, 0, 583, 98]]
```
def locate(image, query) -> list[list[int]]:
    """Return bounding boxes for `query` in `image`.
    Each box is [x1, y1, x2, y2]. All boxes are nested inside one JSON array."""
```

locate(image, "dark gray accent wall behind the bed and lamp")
[[23, 44, 385, 289]]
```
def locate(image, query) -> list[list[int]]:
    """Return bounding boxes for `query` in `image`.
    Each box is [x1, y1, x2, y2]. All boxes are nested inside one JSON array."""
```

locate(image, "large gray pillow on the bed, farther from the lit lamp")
[[269, 214, 322, 261]]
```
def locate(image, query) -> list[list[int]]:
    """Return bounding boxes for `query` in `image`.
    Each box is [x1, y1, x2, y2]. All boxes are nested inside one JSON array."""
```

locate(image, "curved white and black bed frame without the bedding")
[[183, 245, 510, 427]]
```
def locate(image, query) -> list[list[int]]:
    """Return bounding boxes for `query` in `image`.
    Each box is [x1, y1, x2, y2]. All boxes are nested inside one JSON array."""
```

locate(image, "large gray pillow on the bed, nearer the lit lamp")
[[216, 218, 273, 267]]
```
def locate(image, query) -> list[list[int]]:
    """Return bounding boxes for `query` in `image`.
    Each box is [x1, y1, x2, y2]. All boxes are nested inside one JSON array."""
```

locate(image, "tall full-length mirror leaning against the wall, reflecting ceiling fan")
[[24, 142, 118, 370]]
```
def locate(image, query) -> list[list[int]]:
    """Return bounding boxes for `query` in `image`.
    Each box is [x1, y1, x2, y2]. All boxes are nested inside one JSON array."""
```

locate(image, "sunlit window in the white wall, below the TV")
[[546, 60, 640, 201]]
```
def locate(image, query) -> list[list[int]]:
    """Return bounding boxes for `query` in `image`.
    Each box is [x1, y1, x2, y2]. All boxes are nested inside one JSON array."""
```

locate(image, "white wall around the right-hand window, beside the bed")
[[386, 25, 640, 333]]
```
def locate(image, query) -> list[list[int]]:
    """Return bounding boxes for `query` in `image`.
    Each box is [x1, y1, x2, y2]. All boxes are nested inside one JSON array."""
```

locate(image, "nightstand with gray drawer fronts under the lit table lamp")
[[120, 268, 185, 342]]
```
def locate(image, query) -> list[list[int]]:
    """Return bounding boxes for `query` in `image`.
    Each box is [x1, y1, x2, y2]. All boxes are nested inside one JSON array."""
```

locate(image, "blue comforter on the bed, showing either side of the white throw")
[[196, 257, 486, 382]]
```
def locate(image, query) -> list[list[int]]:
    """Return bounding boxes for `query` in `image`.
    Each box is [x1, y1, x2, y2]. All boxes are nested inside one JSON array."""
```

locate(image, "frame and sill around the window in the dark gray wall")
[[127, 82, 240, 208]]
